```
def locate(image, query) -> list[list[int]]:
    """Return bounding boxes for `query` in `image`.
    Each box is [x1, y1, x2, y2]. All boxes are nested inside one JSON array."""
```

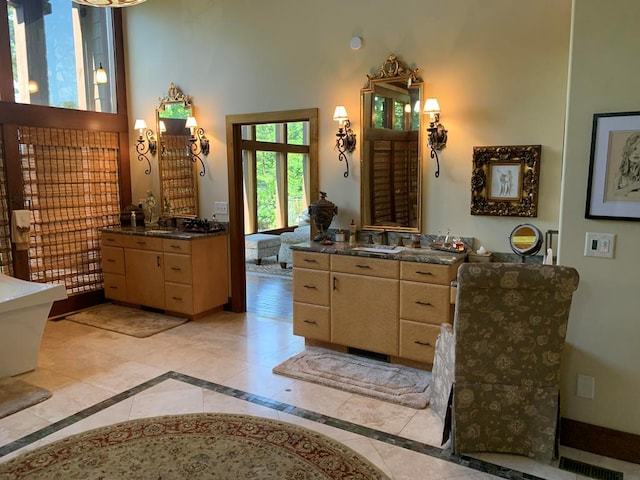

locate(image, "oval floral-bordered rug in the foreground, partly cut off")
[[0, 413, 388, 480]]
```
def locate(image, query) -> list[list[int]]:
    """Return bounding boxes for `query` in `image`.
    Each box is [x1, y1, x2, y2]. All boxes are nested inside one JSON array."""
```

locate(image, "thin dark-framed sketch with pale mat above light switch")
[[585, 112, 640, 221]]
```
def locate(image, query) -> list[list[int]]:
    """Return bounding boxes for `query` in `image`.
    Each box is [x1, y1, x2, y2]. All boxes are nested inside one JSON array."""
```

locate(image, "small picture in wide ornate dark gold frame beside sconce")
[[471, 145, 542, 217]]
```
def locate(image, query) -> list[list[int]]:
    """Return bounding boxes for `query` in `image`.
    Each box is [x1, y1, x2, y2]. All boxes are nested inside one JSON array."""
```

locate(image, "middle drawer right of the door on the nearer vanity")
[[400, 281, 451, 325]]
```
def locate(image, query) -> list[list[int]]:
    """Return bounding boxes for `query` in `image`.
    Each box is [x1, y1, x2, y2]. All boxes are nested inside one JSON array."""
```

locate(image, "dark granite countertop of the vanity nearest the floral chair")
[[290, 242, 467, 265]]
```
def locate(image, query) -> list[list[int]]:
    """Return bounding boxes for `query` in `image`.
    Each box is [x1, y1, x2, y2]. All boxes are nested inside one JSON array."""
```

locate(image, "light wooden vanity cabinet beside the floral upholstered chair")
[[293, 250, 462, 368]]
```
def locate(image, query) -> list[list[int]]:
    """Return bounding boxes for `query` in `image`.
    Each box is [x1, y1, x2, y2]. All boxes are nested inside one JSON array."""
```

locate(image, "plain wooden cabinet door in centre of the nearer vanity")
[[331, 273, 400, 355]]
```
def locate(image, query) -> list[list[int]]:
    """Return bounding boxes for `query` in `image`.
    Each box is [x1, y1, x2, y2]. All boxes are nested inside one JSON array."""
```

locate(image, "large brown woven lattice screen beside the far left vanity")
[[19, 127, 120, 293]]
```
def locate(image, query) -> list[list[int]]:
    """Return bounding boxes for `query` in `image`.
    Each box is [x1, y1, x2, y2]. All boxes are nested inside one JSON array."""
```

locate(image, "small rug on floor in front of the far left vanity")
[[66, 303, 188, 338]]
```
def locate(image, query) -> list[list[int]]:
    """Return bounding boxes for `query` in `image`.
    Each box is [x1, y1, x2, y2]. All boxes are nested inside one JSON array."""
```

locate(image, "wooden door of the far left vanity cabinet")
[[124, 248, 164, 308]]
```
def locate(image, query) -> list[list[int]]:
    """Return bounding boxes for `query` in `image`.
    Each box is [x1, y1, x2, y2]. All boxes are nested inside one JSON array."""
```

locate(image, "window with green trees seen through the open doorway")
[[242, 121, 309, 233]]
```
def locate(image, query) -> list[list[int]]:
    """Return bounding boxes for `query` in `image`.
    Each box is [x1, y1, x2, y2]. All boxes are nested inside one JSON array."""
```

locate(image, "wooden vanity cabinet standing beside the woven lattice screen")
[[102, 232, 229, 318]]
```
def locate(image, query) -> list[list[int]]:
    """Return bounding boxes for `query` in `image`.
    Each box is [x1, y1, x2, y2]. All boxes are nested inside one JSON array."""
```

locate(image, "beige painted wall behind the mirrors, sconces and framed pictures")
[[125, 0, 640, 434]]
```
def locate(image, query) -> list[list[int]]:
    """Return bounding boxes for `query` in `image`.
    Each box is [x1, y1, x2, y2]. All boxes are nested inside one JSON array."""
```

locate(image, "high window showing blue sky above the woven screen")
[[7, 0, 116, 113]]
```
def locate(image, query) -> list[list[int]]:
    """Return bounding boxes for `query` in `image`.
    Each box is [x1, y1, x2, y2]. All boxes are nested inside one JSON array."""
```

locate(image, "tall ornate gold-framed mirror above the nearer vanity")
[[360, 55, 424, 232]]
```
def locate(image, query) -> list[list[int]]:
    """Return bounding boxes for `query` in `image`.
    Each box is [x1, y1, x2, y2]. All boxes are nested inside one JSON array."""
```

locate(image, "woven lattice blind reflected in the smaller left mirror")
[[160, 135, 198, 215]]
